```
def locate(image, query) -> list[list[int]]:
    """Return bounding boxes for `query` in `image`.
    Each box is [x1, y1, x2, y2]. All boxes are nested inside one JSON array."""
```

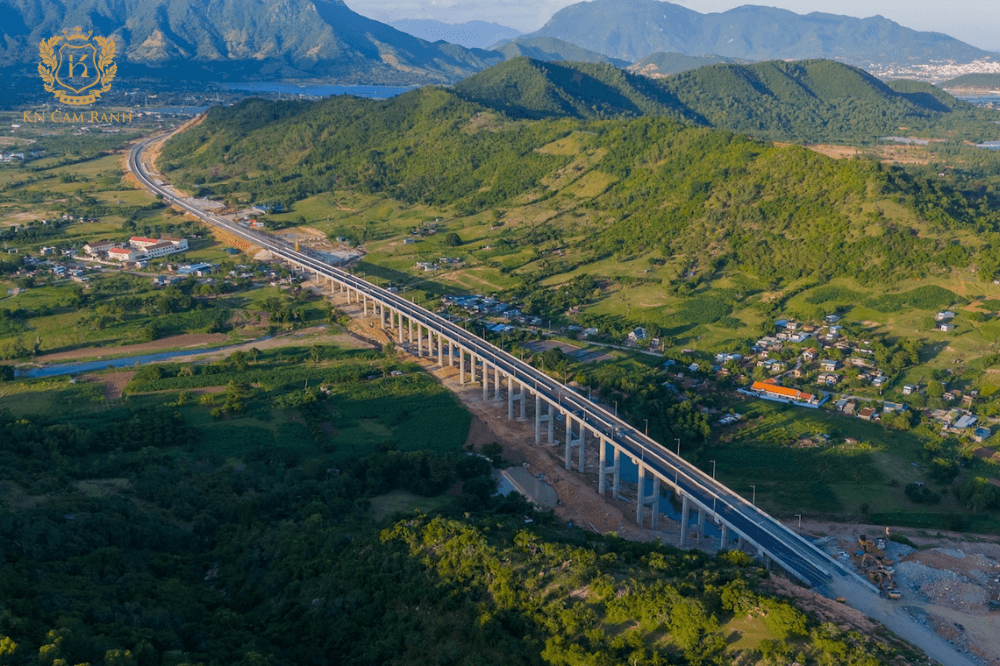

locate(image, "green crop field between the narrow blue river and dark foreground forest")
[[0, 345, 470, 460]]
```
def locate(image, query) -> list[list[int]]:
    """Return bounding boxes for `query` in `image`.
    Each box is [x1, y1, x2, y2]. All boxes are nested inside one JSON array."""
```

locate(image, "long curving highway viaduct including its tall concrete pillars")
[[128, 136, 860, 592]]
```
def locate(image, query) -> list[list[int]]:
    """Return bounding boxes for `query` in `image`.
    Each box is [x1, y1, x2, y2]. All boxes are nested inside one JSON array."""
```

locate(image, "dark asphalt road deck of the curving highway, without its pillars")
[[128, 135, 860, 591]]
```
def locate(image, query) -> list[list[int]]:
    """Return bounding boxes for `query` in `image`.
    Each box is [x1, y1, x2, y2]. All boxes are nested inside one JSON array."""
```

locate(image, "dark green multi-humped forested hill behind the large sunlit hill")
[[455, 59, 1000, 143]]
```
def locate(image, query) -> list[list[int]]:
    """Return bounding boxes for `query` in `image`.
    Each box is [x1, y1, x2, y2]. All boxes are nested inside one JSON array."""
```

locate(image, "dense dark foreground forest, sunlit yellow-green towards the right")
[[0, 394, 913, 666]]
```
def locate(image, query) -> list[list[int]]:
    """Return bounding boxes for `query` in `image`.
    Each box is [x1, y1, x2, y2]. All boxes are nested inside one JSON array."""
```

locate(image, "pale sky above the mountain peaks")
[[354, 0, 1000, 51]]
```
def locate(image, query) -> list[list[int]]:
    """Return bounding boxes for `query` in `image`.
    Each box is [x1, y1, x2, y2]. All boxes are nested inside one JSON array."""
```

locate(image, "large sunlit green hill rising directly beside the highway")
[[160, 87, 1000, 282]]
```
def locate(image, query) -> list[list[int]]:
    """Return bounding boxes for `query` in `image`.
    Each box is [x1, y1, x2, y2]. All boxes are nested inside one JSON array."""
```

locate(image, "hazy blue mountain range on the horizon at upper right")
[[525, 0, 997, 66]]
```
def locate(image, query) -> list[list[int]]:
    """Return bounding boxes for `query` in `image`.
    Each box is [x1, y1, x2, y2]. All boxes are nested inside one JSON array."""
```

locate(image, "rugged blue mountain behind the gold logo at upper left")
[[0, 0, 503, 85]]
